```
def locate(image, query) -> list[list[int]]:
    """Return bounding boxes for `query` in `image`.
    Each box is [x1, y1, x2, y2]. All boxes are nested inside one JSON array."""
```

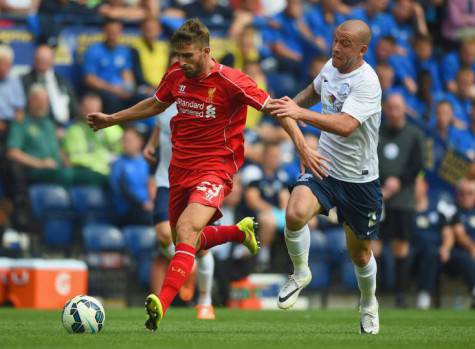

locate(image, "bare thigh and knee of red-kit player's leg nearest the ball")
[[176, 202, 217, 243]]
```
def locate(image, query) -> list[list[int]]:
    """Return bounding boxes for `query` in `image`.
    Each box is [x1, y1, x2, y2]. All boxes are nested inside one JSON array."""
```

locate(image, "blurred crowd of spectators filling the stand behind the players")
[[0, 0, 475, 308]]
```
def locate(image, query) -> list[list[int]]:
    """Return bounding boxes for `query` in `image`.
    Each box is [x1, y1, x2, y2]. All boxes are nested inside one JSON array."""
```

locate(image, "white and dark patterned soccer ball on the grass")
[[61, 296, 106, 333]]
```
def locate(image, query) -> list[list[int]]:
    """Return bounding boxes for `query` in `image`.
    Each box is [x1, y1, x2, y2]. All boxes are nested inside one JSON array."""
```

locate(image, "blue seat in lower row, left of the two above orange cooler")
[[82, 223, 125, 252]]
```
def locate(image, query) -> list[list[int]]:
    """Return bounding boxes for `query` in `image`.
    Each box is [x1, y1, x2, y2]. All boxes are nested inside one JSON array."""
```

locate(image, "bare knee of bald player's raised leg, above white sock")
[[285, 185, 322, 229]]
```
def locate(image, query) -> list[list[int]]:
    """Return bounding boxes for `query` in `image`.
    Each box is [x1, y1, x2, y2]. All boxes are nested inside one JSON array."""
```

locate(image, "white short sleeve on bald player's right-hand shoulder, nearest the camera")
[[341, 78, 381, 124]]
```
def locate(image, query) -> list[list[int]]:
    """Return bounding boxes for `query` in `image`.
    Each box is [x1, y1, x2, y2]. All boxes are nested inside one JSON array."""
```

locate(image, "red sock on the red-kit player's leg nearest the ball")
[[159, 243, 196, 314]]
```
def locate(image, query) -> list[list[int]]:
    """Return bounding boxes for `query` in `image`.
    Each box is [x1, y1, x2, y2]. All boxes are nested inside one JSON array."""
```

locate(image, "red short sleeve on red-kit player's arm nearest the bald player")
[[225, 69, 269, 110]]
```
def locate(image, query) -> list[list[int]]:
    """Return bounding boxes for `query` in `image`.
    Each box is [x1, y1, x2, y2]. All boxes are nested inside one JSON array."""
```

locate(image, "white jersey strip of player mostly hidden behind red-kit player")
[[155, 103, 178, 188]]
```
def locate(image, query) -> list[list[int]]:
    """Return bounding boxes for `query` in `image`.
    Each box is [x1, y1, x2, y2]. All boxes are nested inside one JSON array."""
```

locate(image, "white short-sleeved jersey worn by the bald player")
[[313, 59, 381, 183]]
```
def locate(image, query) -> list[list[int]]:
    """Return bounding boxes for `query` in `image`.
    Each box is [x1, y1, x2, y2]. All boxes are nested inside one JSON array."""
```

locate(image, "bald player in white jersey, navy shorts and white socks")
[[272, 20, 382, 334]]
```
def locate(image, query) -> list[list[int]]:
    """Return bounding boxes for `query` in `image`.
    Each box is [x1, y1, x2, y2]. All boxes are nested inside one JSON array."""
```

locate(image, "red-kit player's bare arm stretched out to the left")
[[87, 97, 169, 131]]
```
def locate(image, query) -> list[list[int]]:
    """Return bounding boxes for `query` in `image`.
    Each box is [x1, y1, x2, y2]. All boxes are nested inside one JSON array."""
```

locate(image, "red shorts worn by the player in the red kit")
[[168, 165, 233, 227]]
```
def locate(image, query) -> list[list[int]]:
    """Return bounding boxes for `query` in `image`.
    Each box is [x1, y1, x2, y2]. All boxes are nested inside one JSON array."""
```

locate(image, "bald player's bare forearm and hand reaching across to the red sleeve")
[[271, 96, 360, 137]]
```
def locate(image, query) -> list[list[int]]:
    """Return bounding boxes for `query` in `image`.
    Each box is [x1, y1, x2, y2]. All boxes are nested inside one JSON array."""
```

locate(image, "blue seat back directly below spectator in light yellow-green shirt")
[[69, 185, 112, 224]]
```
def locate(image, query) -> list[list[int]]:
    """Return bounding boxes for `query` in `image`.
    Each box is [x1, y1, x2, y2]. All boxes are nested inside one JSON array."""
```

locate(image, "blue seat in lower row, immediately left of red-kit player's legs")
[[122, 225, 157, 259]]
